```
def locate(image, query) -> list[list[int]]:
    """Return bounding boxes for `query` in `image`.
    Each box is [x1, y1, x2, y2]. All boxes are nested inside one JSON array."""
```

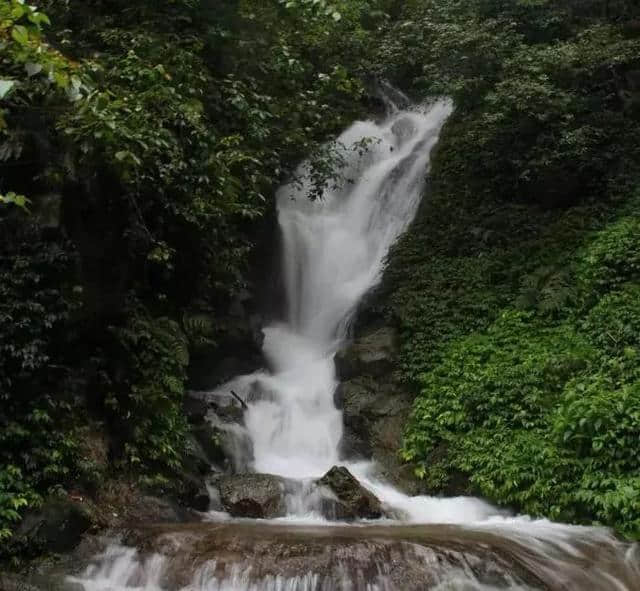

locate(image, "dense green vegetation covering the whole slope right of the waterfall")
[[379, 0, 640, 536]]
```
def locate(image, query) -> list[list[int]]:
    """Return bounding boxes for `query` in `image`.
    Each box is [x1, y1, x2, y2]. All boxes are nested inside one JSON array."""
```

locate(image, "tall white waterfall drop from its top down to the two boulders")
[[245, 100, 452, 478]]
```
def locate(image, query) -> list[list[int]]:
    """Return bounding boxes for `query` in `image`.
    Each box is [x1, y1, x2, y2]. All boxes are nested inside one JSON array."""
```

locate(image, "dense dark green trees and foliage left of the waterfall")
[[0, 0, 382, 542]]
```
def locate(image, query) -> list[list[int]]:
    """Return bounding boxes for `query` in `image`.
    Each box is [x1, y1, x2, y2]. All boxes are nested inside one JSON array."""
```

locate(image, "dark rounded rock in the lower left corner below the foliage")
[[17, 496, 92, 552]]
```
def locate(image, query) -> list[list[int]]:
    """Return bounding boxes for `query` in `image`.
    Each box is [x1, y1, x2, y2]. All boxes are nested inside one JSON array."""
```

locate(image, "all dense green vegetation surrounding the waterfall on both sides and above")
[[0, 0, 640, 560]]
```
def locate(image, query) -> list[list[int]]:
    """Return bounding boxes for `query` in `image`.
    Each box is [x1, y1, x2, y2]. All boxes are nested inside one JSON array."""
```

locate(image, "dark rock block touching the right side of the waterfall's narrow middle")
[[335, 327, 396, 380]]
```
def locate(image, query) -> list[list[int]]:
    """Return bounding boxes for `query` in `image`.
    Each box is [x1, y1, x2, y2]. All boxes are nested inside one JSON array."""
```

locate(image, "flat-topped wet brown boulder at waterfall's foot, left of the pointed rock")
[[219, 474, 286, 519]]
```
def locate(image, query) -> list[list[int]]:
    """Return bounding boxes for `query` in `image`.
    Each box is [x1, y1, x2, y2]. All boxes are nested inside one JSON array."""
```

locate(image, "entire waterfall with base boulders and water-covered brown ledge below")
[[64, 100, 640, 591]]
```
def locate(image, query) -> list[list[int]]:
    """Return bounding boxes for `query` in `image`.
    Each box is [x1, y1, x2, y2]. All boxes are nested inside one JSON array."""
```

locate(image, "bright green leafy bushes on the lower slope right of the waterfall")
[[404, 292, 640, 535]]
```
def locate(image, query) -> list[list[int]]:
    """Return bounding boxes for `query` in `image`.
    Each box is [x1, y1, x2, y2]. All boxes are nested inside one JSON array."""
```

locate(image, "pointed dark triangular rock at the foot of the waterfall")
[[318, 466, 383, 520]]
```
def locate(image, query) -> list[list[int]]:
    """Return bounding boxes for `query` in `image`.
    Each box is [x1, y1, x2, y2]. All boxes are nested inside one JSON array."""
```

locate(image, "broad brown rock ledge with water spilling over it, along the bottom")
[[74, 523, 560, 591]]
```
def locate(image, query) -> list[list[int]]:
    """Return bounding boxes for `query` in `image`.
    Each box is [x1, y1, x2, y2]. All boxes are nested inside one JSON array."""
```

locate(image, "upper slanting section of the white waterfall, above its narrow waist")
[[277, 100, 452, 344]]
